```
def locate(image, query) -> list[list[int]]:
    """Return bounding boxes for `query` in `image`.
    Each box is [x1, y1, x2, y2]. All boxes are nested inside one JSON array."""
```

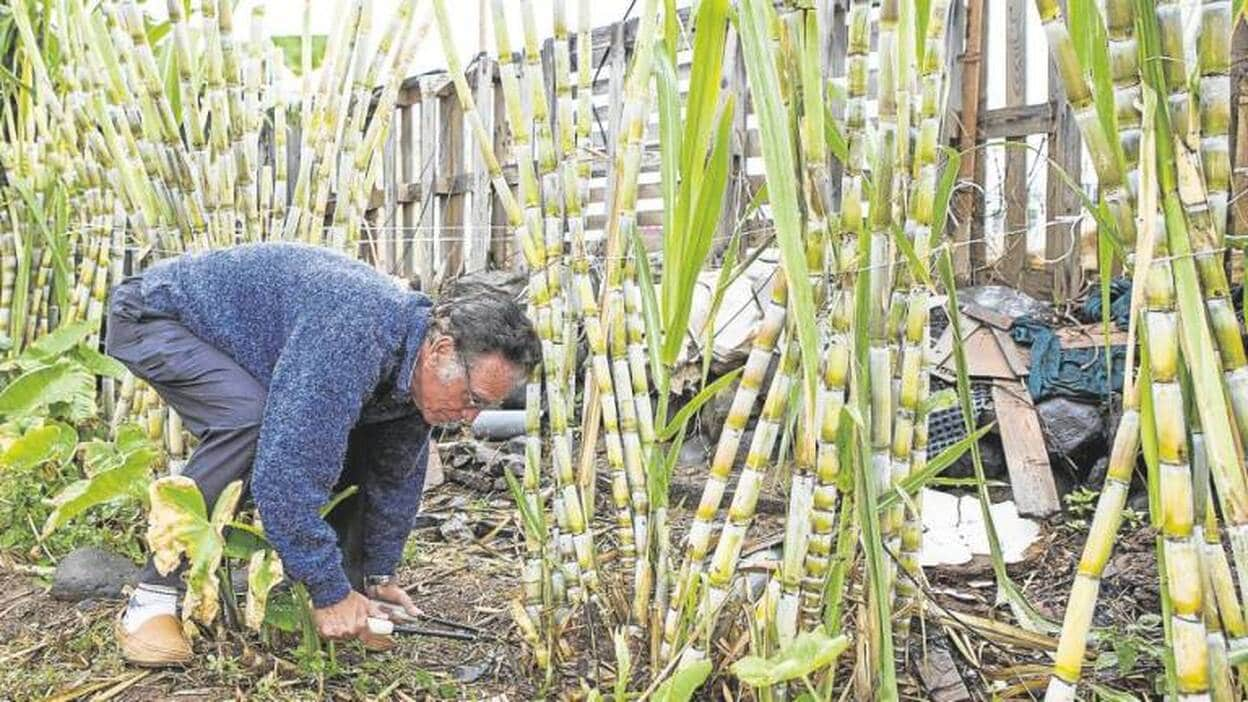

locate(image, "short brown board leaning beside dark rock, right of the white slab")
[[992, 380, 1061, 517]]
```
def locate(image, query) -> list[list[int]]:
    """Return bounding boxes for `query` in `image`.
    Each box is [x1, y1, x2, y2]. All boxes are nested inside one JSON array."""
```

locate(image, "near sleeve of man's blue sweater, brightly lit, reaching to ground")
[[251, 312, 383, 607]]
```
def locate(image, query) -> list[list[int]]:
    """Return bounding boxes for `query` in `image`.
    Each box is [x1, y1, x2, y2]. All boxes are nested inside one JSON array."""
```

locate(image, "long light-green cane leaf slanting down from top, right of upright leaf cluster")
[[736, 0, 820, 411]]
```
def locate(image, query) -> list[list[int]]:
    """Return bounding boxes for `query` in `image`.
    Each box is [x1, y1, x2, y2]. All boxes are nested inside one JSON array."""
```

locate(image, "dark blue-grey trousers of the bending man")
[[105, 279, 364, 590]]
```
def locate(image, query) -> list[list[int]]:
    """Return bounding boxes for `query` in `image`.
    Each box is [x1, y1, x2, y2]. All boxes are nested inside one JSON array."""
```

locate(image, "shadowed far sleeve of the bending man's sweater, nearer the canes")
[[362, 415, 429, 575]]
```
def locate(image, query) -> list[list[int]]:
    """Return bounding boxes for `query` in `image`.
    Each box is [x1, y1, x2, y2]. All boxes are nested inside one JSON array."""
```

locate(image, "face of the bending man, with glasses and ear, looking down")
[[416, 336, 520, 425]]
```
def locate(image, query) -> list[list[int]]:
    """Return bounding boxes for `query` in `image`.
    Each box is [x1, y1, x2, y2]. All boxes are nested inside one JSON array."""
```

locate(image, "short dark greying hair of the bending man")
[[432, 280, 542, 376]]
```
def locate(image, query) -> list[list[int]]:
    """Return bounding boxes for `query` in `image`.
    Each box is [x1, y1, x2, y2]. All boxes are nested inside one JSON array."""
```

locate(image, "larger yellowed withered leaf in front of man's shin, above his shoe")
[[147, 476, 242, 623]]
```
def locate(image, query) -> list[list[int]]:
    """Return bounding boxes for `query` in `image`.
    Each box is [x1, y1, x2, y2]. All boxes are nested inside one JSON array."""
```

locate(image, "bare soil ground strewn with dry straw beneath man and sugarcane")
[[0, 472, 1161, 701]]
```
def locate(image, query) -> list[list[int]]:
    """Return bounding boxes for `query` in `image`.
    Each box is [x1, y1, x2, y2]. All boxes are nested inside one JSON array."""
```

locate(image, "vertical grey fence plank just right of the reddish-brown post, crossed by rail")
[[996, 0, 1028, 286]]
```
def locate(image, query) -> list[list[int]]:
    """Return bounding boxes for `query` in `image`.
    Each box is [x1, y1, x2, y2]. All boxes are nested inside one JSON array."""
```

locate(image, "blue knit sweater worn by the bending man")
[[141, 244, 431, 607]]
